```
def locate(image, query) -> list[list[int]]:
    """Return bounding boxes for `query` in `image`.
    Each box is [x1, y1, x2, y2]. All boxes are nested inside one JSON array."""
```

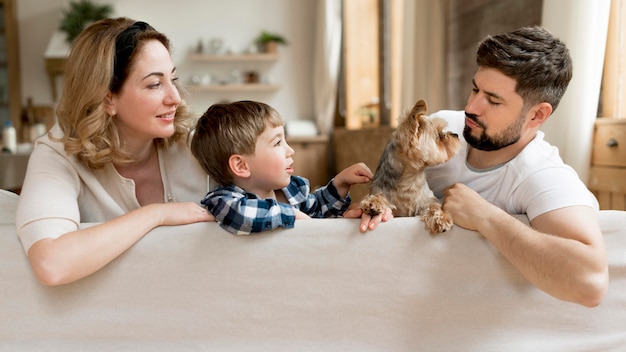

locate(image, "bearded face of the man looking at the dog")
[[463, 68, 527, 151]]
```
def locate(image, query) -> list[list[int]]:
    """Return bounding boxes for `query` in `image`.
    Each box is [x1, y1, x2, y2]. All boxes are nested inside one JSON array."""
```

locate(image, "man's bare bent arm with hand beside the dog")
[[443, 184, 608, 307]]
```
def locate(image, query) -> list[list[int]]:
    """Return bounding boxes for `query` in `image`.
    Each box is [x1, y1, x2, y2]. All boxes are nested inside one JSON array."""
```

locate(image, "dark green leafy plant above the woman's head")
[[59, 0, 113, 43]]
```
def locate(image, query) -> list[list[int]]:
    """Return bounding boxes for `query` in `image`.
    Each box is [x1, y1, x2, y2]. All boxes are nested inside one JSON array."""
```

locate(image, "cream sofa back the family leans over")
[[0, 190, 626, 352]]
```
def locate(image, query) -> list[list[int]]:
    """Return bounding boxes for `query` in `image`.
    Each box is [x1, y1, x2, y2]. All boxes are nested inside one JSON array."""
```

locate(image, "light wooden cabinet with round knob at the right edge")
[[589, 118, 626, 210]]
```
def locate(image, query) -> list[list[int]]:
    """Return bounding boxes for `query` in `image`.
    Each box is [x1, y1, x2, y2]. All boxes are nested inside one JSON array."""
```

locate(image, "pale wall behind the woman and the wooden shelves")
[[17, 0, 316, 120]]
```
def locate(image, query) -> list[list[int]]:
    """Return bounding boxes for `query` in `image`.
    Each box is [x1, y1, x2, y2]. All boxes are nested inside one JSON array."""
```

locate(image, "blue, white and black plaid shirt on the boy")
[[200, 176, 351, 235]]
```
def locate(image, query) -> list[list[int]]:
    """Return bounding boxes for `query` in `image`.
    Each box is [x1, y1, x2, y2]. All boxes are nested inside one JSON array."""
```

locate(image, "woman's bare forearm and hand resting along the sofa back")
[[28, 203, 213, 285]]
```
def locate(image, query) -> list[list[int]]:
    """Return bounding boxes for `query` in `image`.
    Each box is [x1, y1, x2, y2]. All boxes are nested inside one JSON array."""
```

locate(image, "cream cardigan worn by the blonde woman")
[[15, 125, 209, 252]]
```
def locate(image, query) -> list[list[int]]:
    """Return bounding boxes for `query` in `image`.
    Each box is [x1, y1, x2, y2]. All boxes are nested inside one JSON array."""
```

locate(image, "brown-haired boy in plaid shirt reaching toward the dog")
[[191, 101, 373, 235]]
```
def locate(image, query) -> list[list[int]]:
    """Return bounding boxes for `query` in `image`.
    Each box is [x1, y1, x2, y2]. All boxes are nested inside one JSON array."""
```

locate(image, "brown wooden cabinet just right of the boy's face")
[[287, 136, 330, 191]]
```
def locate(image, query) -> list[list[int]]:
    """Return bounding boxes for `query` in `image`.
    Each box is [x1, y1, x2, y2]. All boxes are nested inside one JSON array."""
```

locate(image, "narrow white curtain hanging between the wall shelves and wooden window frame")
[[313, 0, 342, 135]]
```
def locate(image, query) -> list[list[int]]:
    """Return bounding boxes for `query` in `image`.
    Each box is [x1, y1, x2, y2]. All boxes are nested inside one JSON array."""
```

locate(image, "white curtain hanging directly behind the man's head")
[[542, 0, 611, 182]]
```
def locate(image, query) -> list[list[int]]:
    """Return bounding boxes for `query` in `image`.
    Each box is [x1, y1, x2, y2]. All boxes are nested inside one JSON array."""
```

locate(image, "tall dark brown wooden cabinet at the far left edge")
[[0, 0, 22, 133]]
